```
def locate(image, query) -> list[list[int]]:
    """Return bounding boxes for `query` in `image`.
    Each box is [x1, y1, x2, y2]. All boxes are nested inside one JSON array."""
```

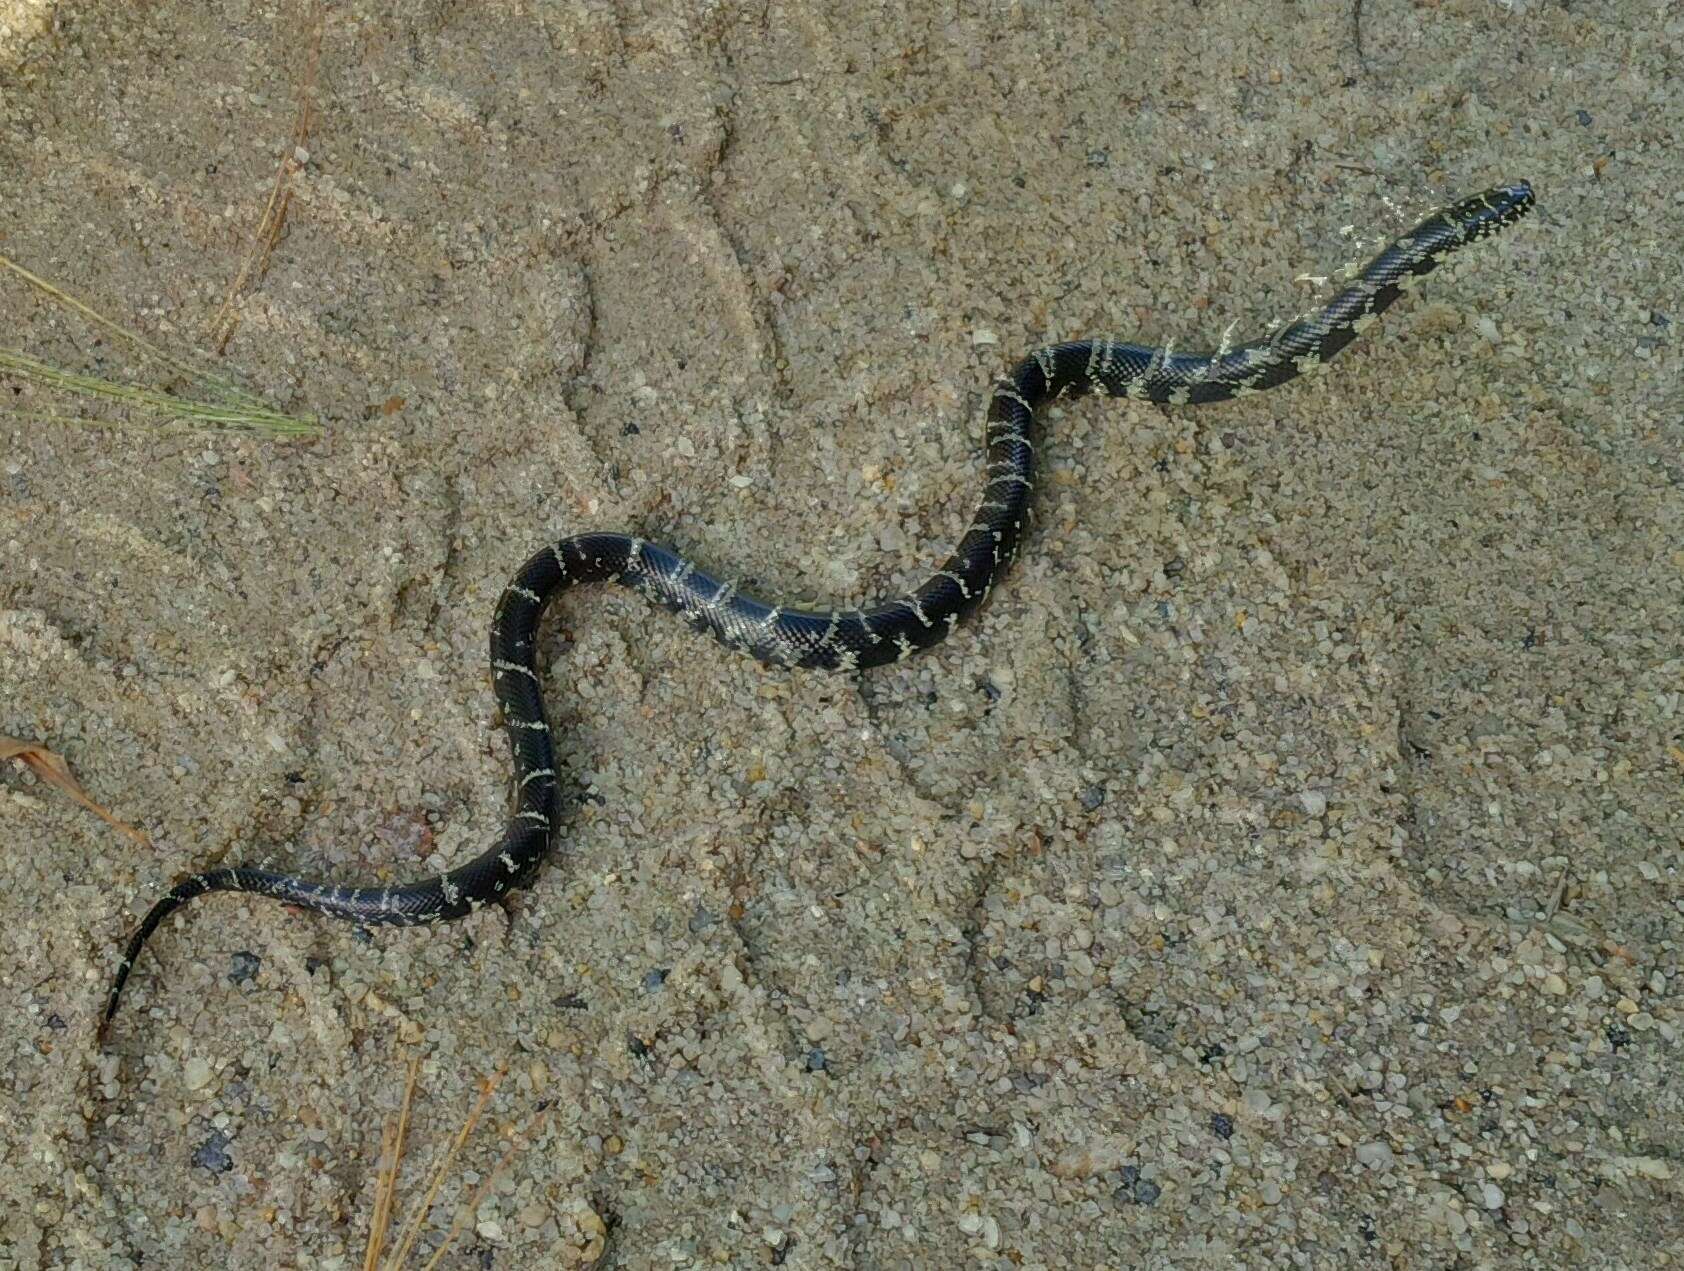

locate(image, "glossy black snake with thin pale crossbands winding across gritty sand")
[[99, 182, 1532, 1040]]
